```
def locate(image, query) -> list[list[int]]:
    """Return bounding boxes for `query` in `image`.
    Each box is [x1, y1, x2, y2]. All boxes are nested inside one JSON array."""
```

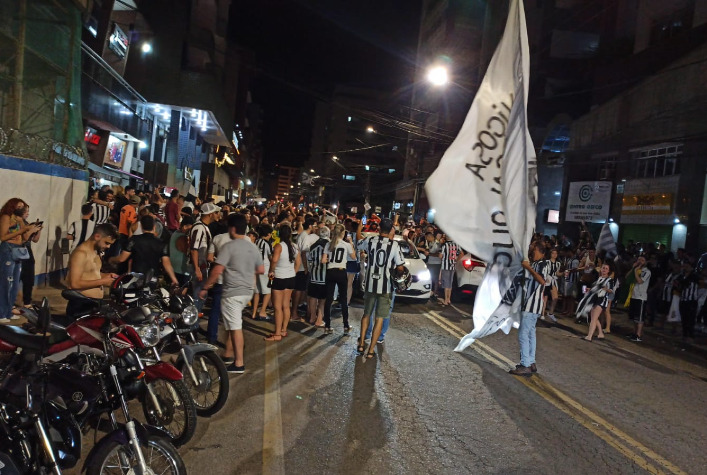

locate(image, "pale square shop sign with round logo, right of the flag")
[[565, 181, 612, 223]]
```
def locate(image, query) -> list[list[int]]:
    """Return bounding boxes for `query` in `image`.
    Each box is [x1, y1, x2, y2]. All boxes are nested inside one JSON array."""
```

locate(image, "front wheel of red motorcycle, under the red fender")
[[141, 379, 196, 447]]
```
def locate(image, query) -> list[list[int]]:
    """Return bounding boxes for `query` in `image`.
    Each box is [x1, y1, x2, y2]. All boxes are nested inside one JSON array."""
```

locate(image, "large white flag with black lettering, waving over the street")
[[425, 0, 537, 351]]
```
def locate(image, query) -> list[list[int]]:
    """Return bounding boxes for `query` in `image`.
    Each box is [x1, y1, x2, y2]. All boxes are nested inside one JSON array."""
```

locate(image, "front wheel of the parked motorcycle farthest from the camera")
[[177, 351, 230, 417]]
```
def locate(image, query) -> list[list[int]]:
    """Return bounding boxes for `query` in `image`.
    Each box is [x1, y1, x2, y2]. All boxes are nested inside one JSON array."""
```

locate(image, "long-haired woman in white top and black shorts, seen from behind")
[[265, 223, 302, 341]]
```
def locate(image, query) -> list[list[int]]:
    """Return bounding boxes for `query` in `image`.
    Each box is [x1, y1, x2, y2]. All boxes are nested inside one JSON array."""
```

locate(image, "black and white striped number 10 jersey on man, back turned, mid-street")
[[358, 236, 405, 294]]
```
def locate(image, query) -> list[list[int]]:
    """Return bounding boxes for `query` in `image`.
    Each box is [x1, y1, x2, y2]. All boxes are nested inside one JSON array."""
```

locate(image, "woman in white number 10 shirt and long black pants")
[[322, 224, 356, 333]]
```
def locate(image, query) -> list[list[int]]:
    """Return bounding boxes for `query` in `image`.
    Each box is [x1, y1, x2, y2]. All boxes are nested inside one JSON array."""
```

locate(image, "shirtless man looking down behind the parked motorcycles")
[[66, 223, 118, 316]]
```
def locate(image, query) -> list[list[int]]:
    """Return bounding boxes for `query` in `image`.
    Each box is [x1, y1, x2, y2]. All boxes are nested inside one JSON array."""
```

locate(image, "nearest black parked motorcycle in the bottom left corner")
[[0, 299, 186, 475]]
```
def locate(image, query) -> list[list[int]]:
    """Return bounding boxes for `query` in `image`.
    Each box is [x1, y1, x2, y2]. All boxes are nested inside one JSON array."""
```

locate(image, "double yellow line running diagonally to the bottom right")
[[423, 311, 686, 475]]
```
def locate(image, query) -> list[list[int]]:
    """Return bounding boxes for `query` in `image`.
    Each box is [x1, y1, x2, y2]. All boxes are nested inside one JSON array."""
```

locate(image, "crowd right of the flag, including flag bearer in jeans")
[[505, 231, 707, 376]]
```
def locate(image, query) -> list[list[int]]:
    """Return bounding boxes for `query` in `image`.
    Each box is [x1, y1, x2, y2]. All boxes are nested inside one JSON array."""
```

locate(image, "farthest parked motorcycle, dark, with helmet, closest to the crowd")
[[111, 274, 229, 417]]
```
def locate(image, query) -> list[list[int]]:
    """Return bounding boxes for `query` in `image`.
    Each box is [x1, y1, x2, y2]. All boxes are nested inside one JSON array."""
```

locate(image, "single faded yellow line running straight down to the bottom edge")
[[263, 342, 285, 475]]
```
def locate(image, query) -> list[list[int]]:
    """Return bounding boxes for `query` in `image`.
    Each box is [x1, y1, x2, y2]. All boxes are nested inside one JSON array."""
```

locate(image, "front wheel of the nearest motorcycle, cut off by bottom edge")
[[86, 436, 187, 475]]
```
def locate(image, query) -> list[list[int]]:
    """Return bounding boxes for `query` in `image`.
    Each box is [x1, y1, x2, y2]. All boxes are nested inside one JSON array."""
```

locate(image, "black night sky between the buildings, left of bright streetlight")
[[231, 0, 422, 166]]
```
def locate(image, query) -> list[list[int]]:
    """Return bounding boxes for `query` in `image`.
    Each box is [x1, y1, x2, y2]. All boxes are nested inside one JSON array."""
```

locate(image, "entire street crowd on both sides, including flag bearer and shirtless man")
[[0, 186, 707, 376]]
